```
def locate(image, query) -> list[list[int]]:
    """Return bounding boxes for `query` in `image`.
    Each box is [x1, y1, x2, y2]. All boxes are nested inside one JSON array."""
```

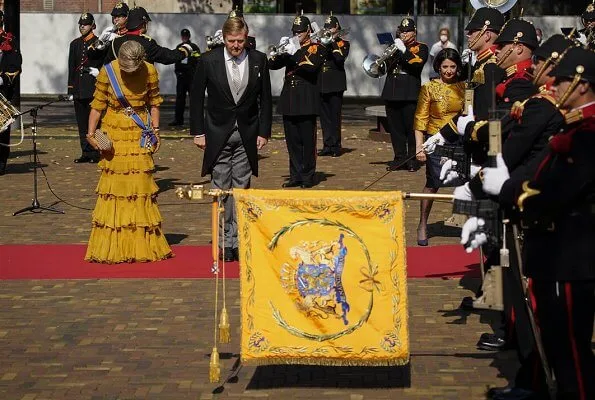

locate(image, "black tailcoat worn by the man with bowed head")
[[190, 47, 273, 176]]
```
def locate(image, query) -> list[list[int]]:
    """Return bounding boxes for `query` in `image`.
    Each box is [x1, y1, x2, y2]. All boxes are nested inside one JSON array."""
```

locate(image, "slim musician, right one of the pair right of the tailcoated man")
[[318, 15, 349, 157]]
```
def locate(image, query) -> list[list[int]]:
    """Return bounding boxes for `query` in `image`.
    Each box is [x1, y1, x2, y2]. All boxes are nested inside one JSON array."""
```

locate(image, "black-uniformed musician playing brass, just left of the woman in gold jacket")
[[381, 18, 430, 171]]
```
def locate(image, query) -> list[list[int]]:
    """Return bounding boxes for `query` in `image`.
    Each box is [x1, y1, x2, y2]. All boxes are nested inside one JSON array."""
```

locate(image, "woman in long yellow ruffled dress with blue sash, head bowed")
[[85, 41, 172, 264]]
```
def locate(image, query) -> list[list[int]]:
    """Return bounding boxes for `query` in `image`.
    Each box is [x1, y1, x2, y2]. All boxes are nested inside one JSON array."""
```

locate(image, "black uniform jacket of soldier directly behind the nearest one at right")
[[470, 86, 564, 198]]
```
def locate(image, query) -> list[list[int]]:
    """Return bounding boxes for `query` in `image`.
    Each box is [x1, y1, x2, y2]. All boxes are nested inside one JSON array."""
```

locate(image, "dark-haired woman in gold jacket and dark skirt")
[[414, 49, 465, 246]]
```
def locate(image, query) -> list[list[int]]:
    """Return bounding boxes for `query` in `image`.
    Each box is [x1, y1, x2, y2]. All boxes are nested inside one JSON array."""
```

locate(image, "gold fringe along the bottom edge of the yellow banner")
[[241, 356, 410, 367]]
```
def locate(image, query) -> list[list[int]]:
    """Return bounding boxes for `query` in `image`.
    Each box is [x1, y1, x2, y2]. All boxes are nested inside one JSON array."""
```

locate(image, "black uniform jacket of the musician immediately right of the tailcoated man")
[[269, 41, 325, 115]]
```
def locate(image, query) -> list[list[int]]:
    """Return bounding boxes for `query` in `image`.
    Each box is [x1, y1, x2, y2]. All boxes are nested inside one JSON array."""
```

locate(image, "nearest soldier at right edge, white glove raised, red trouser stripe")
[[474, 47, 595, 399]]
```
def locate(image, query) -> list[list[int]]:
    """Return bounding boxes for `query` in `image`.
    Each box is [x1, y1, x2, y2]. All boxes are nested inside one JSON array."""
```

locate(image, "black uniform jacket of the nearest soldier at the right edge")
[[500, 105, 595, 281]]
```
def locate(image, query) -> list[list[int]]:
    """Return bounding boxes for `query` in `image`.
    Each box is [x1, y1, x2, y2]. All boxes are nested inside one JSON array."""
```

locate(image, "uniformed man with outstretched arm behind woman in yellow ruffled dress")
[[104, 8, 194, 65]]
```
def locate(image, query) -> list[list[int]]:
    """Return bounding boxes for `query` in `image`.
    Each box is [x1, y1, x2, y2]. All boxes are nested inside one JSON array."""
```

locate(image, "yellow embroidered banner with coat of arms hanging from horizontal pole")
[[233, 189, 409, 366]]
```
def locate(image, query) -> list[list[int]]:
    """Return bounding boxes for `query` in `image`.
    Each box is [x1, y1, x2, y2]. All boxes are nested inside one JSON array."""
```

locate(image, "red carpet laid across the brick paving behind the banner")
[[0, 245, 479, 279]]
